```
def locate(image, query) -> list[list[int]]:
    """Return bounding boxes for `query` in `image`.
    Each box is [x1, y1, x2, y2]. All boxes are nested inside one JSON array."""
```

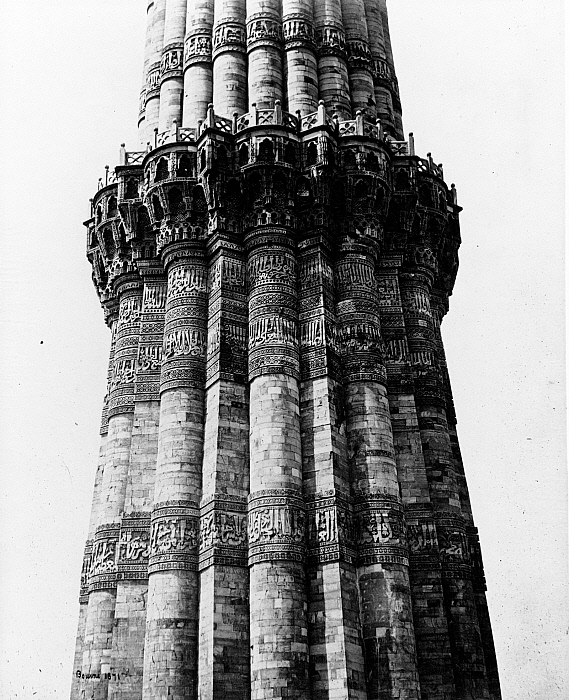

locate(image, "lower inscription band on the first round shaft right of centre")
[[354, 494, 409, 566]]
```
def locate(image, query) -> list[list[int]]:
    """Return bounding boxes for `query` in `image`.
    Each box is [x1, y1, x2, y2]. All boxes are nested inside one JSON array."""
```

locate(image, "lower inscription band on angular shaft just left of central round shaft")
[[199, 494, 247, 571]]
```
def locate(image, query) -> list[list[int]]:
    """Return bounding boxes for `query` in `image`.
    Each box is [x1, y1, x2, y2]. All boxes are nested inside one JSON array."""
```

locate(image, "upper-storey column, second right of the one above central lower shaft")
[[314, 0, 352, 119]]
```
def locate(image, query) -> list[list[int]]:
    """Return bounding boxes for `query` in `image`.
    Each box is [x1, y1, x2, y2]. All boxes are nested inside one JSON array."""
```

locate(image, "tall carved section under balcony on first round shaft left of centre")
[[160, 248, 207, 391]]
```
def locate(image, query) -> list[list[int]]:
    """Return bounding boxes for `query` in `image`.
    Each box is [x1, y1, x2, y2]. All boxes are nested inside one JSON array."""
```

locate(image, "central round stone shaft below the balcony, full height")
[[246, 215, 309, 700]]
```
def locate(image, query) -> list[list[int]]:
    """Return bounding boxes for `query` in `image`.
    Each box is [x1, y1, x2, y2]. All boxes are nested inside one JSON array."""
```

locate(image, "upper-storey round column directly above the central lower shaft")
[[247, 0, 284, 110]]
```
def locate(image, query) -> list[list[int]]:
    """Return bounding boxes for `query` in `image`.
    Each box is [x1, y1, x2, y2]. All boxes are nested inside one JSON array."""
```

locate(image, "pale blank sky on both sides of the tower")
[[0, 0, 569, 700]]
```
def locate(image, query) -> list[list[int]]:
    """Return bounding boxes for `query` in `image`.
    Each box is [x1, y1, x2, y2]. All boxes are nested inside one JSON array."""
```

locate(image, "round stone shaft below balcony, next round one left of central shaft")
[[142, 241, 207, 700]]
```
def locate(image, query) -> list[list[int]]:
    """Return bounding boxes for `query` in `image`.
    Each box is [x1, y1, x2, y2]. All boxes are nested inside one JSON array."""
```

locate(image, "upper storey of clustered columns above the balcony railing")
[[139, 0, 403, 145]]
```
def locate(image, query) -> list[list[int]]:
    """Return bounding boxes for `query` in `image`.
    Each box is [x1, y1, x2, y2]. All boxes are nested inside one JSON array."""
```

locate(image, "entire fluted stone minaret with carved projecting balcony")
[[71, 0, 500, 700]]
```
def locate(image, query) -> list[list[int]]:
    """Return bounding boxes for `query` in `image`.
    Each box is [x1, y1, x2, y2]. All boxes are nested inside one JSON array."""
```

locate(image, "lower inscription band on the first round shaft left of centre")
[[148, 501, 199, 574]]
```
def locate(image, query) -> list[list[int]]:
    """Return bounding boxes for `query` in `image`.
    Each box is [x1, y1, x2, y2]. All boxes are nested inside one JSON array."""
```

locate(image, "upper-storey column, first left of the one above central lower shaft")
[[213, 0, 248, 117]]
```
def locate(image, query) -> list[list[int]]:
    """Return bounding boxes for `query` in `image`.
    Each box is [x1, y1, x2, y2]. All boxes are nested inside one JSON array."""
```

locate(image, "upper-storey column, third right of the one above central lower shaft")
[[342, 0, 377, 118]]
